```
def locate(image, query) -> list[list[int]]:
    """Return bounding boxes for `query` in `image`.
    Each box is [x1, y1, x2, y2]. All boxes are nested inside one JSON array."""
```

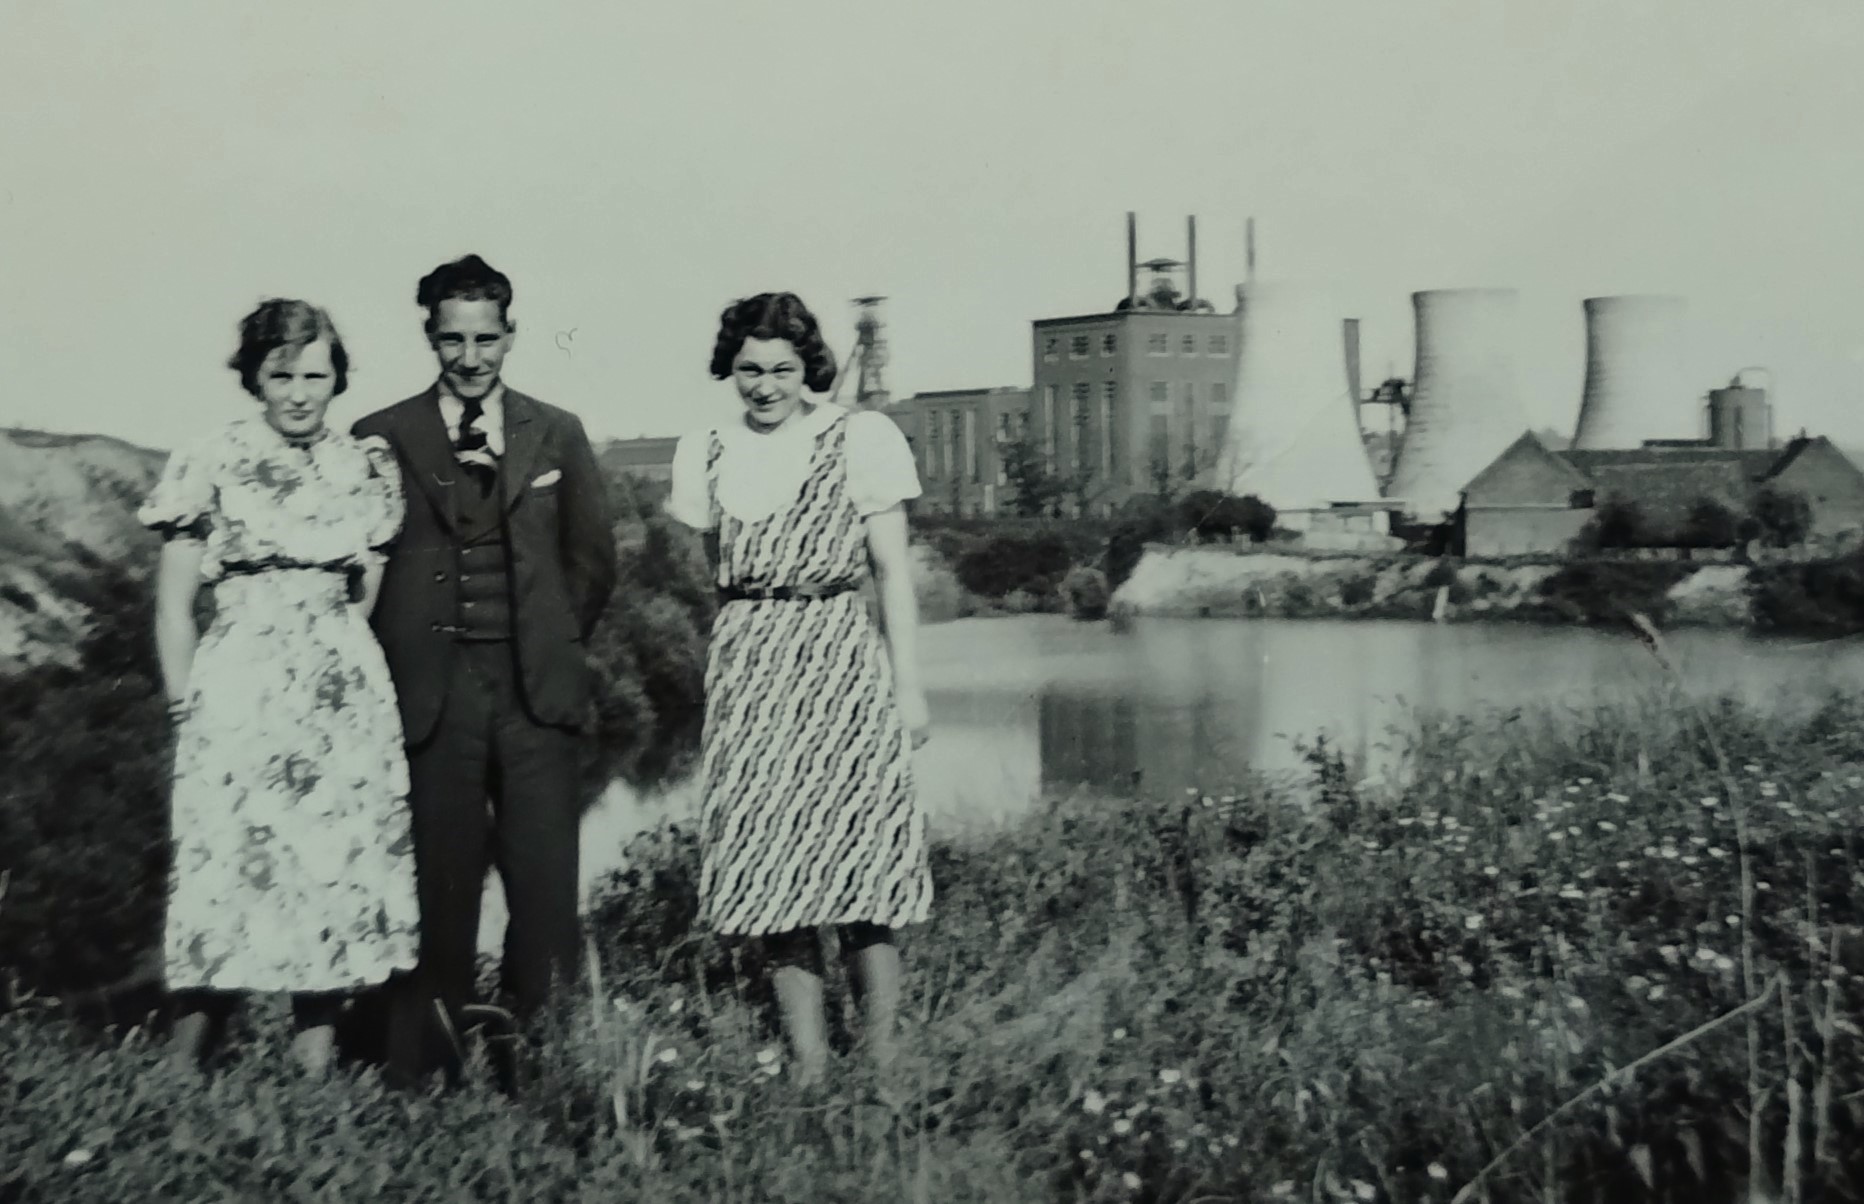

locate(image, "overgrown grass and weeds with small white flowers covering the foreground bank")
[[0, 678, 1864, 1204]]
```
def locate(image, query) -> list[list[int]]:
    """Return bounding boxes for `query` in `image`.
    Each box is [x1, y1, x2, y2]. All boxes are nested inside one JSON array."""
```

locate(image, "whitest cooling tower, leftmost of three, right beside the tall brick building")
[[1217, 283, 1379, 511]]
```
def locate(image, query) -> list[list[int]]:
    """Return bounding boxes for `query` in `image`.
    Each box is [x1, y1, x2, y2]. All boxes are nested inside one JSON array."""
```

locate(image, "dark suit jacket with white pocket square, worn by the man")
[[352, 386, 615, 744]]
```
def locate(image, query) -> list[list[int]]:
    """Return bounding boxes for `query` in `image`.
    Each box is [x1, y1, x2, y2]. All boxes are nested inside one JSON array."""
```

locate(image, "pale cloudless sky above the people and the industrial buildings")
[[0, 0, 1864, 447]]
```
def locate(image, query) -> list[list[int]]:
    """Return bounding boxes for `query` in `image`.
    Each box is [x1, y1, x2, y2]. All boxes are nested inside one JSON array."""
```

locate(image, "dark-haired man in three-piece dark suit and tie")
[[354, 255, 615, 1081]]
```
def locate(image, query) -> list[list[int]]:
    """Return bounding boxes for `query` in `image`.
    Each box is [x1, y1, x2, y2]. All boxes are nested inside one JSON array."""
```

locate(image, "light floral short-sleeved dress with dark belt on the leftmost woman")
[[138, 417, 419, 992]]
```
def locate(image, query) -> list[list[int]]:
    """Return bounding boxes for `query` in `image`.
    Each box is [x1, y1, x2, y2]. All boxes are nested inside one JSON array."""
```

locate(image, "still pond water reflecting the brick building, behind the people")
[[562, 615, 1864, 916]]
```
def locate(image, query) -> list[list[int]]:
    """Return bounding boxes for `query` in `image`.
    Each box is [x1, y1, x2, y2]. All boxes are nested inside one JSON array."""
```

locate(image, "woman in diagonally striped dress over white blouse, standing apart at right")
[[667, 293, 932, 1083]]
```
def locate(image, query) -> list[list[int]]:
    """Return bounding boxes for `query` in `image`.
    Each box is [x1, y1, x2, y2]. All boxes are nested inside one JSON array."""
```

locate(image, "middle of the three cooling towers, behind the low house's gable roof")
[[1385, 289, 1528, 524]]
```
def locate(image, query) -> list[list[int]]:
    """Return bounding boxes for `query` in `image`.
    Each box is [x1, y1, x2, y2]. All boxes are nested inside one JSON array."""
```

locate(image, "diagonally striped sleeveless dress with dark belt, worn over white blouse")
[[699, 416, 932, 936]]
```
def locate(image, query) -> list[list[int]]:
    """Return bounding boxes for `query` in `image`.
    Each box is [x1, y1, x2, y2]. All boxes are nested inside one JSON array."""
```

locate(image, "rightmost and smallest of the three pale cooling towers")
[[1573, 296, 1696, 451]]
